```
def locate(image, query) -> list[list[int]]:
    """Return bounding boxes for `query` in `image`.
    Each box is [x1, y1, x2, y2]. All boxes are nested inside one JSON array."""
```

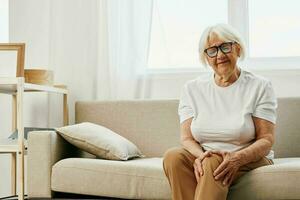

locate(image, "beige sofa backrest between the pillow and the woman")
[[75, 99, 180, 157]]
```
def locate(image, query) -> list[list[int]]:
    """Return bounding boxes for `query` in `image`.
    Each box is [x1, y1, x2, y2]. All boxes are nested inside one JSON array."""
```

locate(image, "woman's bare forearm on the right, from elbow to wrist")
[[237, 138, 272, 165]]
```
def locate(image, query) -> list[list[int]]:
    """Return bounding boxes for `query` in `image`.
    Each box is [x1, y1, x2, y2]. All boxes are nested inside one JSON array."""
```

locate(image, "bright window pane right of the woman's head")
[[249, 0, 300, 58]]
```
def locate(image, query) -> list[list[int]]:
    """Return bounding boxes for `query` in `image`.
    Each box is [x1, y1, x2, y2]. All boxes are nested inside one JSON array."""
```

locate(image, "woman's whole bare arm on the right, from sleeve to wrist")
[[237, 117, 275, 165]]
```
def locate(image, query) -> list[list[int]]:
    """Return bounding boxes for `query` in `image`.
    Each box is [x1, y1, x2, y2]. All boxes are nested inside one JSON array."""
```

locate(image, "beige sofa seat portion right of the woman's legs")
[[228, 158, 300, 200]]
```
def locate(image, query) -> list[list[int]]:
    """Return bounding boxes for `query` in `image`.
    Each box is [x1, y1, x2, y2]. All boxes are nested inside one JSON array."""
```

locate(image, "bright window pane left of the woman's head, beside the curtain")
[[148, 0, 228, 69]]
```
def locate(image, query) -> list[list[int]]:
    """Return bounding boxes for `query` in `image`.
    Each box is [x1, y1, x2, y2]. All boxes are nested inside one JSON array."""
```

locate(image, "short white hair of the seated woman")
[[199, 24, 246, 66]]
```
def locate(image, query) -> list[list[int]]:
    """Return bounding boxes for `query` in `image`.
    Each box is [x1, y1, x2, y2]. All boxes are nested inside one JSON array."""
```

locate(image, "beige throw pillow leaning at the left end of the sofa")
[[56, 122, 144, 160]]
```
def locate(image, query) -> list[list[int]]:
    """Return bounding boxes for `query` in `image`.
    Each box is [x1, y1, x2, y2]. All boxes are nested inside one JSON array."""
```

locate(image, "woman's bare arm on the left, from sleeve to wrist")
[[180, 117, 203, 158]]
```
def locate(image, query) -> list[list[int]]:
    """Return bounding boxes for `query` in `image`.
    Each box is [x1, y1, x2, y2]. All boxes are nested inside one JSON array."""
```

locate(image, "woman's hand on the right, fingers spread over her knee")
[[211, 151, 242, 185]]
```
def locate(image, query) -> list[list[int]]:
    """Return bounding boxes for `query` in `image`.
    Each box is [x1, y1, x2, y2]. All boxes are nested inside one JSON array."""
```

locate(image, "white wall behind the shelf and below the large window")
[[0, 0, 300, 196]]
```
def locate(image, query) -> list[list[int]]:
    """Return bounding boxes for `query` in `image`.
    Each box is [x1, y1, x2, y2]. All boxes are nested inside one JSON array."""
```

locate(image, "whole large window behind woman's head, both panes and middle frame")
[[148, 0, 300, 71]]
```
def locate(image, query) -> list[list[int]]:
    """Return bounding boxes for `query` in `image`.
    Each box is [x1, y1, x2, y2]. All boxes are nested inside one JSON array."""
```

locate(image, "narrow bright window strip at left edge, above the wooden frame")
[[0, 0, 8, 42]]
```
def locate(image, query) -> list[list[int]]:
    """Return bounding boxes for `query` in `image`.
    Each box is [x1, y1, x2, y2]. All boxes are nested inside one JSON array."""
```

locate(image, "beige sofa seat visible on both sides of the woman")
[[51, 158, 300, 200]]
